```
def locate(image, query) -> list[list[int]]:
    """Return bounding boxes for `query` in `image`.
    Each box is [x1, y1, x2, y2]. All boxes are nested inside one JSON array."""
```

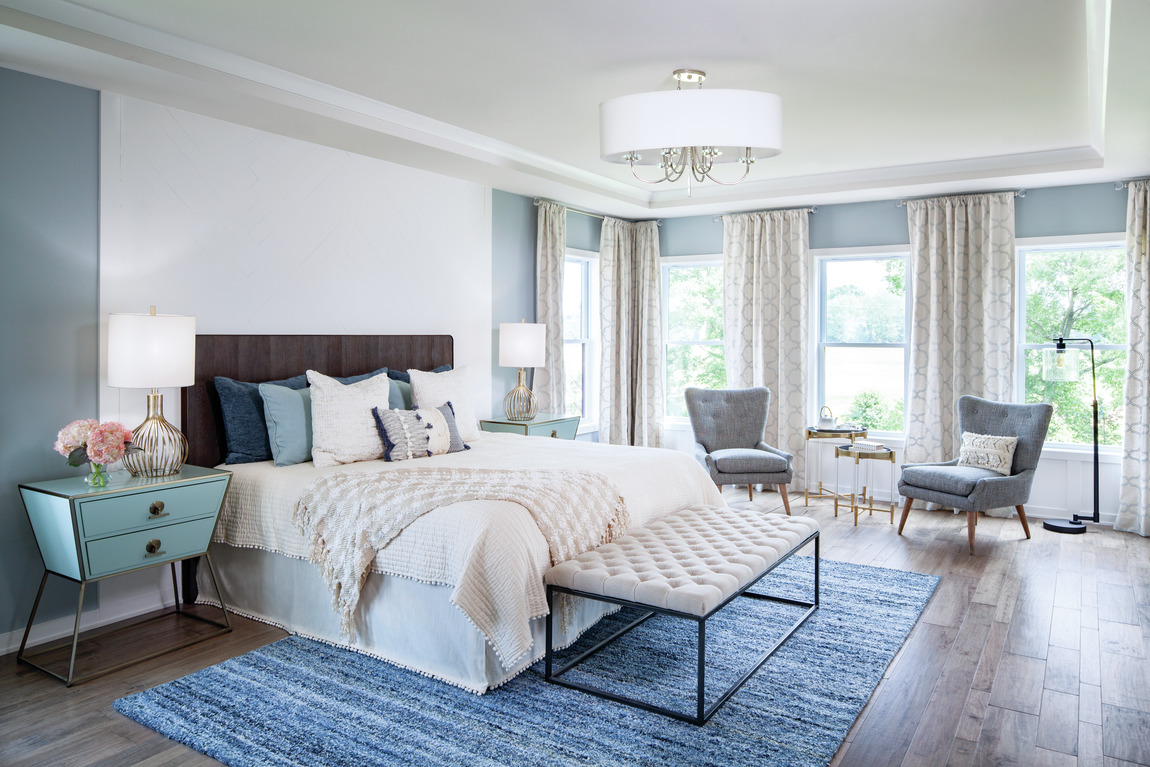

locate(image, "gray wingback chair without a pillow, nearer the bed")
[[684, 386, 795, 514]]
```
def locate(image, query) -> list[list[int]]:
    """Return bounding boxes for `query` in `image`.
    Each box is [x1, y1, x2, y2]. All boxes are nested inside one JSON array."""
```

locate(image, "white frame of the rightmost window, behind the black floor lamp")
[[1014, 232, 1130, 455]]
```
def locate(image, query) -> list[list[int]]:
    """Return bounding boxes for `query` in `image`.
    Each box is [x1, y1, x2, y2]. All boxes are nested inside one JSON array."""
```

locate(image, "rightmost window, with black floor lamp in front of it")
[[1015, 241, 1127, 445]]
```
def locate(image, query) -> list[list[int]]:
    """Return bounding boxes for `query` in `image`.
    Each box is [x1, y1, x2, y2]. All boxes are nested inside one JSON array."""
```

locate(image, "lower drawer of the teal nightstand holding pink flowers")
[[85, 516, 215, 577]]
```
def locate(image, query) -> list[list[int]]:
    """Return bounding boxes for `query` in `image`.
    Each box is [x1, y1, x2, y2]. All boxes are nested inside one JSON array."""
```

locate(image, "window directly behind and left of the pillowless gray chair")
[[662, 264, 727, 417]]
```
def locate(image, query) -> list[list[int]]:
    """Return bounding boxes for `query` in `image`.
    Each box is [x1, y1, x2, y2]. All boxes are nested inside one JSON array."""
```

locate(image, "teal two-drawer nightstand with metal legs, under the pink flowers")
[[16, 466, 231, 687]]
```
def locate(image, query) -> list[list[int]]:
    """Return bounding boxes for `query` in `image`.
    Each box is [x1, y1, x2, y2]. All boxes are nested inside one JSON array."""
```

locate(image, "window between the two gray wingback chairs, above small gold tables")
[[817, 254, 910, 432]]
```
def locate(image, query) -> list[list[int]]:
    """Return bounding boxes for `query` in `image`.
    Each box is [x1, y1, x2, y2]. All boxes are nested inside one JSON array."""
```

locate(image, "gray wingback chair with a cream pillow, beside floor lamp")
[[898, 394, 1053, 554]]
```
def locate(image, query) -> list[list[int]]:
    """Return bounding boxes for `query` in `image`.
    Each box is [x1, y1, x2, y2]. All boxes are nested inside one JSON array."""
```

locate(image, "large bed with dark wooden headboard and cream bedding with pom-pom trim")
[[183, 336, 721, 692]]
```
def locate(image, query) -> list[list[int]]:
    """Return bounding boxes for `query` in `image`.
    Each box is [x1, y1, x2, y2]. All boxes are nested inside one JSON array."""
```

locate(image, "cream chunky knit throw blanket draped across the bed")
[[292, 469, 628, 643]]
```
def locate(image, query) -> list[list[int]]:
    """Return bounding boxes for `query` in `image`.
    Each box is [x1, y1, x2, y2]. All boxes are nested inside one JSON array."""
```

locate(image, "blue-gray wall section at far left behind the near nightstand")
[[0, 69, 100, 634]]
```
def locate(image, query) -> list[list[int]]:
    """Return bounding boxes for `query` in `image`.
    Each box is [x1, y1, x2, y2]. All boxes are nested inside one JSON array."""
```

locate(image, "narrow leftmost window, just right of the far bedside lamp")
[[564, 250, 598, 421]]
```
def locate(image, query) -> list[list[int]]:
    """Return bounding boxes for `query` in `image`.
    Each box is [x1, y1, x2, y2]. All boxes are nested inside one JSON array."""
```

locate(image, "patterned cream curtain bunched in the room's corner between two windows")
[[599, 218, 664, 447]]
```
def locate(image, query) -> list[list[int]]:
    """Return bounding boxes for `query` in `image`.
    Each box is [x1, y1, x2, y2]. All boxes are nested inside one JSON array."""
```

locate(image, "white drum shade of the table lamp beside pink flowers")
[[108, 314, 196, 389]]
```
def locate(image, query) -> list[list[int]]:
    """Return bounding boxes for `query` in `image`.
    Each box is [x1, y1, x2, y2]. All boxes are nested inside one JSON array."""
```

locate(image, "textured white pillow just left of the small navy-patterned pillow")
[[307, 370, 391, 467]]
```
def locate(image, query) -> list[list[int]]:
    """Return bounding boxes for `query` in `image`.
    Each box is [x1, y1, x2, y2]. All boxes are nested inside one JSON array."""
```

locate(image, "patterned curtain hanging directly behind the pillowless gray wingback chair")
[[722, 208, 810, 486]]
